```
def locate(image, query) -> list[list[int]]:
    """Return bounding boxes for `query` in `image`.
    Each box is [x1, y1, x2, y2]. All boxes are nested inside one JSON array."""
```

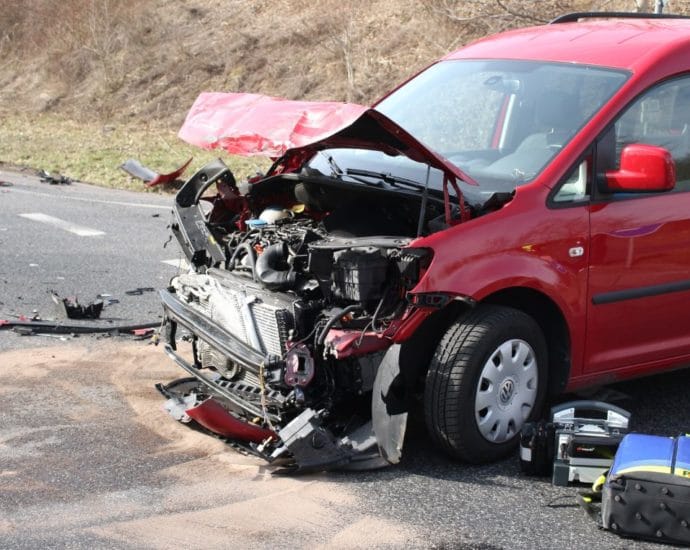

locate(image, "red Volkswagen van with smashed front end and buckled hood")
[[159, 13, 690, 471]]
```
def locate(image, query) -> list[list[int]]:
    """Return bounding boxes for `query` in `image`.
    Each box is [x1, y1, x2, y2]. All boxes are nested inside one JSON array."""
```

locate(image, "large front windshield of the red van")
[[375, 60, 628, 191]]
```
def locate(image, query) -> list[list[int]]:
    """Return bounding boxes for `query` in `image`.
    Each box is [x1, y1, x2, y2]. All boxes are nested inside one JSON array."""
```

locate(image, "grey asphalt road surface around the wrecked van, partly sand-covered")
[[0, 172, 690, 549]]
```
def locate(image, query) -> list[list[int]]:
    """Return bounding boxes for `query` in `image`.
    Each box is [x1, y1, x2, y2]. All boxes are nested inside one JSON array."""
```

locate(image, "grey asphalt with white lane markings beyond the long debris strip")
[[0, 168, 181, 349]]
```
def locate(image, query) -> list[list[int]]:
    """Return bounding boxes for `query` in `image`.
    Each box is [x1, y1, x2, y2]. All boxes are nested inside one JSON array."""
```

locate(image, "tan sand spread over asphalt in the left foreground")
[[0, 340, 424, 548]]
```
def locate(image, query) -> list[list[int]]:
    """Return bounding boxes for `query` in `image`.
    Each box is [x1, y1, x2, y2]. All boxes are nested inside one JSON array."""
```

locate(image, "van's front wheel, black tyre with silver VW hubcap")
[[424, 304, 547, 464]]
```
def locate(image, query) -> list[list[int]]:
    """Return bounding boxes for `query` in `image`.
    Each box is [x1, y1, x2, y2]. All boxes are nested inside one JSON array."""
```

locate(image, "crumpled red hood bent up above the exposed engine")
[[178, 92, 476, 184]]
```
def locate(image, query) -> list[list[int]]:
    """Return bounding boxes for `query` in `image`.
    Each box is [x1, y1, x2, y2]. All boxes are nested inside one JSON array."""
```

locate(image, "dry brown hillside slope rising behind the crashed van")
[[0, 0, 676, 127]]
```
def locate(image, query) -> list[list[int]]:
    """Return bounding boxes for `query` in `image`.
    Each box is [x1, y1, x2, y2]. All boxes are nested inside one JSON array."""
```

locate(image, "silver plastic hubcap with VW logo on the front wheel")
[[474, 340, 538, 443]]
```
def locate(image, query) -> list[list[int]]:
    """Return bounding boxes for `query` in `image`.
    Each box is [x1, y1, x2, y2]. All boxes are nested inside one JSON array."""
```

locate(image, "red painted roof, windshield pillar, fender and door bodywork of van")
[[406, 20, 690, 389]]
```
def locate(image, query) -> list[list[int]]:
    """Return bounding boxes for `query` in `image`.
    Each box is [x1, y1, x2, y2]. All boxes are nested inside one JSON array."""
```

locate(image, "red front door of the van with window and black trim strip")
[[584, 76, 690, 374]]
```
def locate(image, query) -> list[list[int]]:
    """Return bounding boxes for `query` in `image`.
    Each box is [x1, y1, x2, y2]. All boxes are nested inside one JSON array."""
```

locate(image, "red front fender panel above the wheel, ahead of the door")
[[412, 185, 589, 386]]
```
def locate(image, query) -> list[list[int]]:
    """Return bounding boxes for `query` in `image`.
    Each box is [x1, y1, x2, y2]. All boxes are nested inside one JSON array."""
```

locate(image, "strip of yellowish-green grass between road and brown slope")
[[0, 114, 270, 191]]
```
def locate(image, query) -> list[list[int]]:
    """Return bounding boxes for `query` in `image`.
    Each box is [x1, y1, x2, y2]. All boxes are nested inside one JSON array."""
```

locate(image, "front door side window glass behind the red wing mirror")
[[612, 77, 690, 192]]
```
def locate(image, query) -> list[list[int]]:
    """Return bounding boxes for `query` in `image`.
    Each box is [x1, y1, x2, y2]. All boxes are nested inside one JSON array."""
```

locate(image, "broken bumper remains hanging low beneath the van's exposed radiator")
[[157, 290, 407, 473]]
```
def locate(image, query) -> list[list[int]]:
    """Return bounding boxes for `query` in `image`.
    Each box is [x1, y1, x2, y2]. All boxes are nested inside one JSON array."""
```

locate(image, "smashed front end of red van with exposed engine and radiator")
[[158, 103, 490, 471]]
